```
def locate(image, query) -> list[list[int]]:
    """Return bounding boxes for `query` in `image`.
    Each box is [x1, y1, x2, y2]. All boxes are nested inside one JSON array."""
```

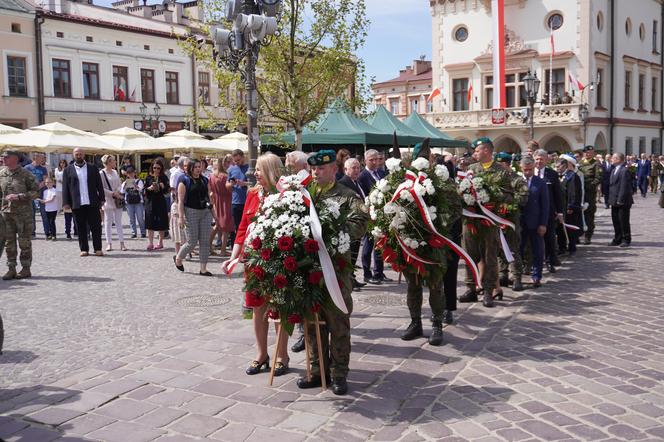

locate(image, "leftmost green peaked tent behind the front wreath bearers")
[[261, 100, 392, 146]]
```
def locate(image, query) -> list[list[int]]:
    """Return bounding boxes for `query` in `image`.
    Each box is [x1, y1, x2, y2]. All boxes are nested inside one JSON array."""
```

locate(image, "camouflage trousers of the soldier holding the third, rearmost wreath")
[[463, 223, 500, 293]]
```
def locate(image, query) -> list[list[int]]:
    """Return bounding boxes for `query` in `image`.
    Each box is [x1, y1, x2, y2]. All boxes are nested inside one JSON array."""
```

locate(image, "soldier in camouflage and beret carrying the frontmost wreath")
[[297, 150, 369, 395]]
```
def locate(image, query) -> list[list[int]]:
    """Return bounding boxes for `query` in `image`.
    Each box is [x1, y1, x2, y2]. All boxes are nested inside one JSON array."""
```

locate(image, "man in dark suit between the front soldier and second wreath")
[[357, 149, 392, 284]]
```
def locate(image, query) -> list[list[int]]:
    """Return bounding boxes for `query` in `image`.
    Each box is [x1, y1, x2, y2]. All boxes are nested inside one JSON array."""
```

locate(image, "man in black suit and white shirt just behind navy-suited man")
[[533, 149, 563, 273]]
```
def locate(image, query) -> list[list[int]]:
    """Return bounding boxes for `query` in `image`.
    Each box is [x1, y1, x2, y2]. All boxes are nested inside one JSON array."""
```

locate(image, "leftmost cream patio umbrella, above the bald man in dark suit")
[[0, 123, 115, 154]]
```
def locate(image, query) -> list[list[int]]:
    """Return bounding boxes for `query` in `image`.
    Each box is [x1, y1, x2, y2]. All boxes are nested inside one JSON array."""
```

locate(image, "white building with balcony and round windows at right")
[[428, 0, 664, 154]]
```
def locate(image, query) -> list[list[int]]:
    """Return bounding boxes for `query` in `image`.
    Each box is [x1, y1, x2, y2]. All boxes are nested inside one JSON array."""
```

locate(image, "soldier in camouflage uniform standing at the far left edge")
[[0, 151, 39, 280]]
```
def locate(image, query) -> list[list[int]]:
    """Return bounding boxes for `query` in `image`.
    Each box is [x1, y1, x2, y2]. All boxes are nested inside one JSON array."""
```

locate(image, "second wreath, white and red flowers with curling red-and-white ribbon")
[[366, 158, 461, 282]]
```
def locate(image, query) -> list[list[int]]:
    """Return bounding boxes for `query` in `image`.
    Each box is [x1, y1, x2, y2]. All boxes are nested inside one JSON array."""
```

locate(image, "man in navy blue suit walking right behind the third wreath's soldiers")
[[520, 157, 551, 287]]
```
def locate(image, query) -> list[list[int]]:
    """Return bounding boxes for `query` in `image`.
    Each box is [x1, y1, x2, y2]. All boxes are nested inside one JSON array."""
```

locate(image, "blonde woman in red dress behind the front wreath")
[[221, 152, 289, 376]]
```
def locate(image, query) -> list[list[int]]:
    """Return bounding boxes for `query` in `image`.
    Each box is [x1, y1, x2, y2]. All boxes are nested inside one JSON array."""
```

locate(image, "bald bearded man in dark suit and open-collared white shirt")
[[62, 148, 105, 256]]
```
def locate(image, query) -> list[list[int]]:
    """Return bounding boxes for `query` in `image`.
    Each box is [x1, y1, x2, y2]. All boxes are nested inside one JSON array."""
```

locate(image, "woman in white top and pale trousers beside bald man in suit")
[[99, 155, 127, 252]]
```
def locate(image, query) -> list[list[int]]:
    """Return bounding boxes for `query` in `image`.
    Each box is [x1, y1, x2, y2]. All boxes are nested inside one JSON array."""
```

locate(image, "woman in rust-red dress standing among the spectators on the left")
[[208, 155, 235, 256]]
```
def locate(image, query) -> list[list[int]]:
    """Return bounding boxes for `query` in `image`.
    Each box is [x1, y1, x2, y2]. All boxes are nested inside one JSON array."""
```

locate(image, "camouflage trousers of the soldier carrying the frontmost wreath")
[[307, 281, 353, 378]]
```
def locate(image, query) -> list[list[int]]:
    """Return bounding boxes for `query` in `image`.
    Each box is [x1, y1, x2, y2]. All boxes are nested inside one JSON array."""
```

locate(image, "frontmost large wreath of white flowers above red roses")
[[244, 175, 352, 334]]
